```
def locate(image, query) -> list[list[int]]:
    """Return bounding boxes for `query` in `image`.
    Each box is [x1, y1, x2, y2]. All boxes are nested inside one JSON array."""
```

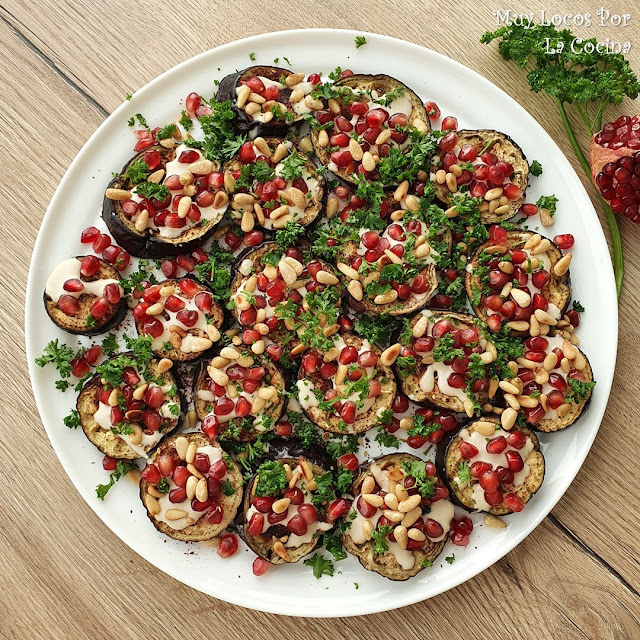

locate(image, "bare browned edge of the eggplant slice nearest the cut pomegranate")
[[433, 129, 529, 224]]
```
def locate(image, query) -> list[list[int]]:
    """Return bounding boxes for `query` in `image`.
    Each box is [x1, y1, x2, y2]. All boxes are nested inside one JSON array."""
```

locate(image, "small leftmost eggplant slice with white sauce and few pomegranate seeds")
[[43, 255, 127, 336]]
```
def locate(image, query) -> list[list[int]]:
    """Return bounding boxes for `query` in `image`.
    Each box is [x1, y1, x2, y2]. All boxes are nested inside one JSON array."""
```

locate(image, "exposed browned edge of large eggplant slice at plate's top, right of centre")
[[309, 73, 430, 186]]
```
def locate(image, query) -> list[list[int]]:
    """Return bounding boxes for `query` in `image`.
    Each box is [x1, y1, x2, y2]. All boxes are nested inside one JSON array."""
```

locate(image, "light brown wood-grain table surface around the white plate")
[[0, 0, 640, 640]]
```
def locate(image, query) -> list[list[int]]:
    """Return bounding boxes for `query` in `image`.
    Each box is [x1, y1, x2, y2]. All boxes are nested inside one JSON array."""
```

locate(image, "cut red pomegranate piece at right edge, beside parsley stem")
[[590, 115, 640, 222]]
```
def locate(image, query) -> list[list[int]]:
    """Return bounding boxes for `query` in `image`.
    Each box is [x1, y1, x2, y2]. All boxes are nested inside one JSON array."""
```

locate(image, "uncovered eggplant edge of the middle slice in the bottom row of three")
[[242, 458, 327, 564]]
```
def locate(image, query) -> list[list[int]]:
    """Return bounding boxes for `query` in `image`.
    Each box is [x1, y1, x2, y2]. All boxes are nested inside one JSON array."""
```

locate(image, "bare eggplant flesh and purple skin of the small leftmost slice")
[[42, 256, 128, 336]]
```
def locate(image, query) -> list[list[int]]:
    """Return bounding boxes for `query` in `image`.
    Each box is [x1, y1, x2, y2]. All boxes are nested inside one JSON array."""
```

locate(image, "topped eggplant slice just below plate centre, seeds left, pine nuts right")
[[296, 333, 396, 434]]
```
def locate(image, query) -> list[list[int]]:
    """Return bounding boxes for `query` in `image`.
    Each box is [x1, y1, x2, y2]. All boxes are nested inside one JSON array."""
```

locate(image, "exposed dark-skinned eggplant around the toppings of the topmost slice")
[[216, 66, 302, 136]]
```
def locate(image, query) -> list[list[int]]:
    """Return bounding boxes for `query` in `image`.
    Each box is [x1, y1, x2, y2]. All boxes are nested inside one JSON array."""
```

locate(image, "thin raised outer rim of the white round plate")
[[25, 28, 619, 618]]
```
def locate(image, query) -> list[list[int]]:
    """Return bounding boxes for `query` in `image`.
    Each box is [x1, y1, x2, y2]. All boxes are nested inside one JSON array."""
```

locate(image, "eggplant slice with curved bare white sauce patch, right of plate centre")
[[396, 309, 495, 416]]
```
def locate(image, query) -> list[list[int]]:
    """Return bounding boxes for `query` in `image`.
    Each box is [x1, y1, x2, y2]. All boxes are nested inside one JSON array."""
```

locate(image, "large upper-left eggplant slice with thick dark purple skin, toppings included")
[[102, 144, 229, 258]]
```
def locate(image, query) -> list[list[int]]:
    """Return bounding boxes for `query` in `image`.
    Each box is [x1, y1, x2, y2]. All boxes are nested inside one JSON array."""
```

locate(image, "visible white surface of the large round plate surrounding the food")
[[26, 29, 618, 617]]
